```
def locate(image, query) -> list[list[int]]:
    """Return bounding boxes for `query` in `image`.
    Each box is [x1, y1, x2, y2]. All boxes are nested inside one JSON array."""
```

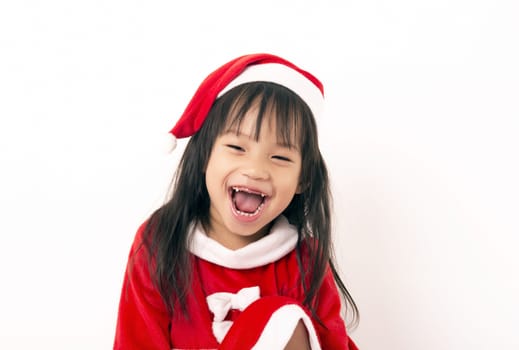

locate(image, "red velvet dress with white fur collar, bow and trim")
[[114, 217, 357, 350]]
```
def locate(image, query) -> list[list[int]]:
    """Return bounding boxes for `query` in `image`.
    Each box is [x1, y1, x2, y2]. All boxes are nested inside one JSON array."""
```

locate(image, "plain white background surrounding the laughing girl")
[[0, 0, 519, 350]]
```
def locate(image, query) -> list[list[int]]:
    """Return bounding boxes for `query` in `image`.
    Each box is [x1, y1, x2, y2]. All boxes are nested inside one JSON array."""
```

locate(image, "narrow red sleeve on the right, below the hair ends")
[[314, 267, 358, 350]]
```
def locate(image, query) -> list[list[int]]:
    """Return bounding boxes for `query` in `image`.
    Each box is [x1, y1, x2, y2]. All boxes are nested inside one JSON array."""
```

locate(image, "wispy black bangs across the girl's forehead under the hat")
[[218, 82, 313, 150]]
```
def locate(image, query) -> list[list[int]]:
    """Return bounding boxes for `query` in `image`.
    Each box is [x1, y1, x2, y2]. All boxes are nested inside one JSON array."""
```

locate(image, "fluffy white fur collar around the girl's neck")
[[189, 216, 297, 269]]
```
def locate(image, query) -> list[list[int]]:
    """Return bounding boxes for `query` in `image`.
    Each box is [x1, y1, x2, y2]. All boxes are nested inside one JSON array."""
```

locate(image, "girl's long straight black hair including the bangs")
[[139, 82, 358, 323]]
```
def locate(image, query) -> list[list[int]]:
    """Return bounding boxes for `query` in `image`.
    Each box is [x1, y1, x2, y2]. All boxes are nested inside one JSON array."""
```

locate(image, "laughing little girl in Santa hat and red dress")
[[114, 54, 358, 350]]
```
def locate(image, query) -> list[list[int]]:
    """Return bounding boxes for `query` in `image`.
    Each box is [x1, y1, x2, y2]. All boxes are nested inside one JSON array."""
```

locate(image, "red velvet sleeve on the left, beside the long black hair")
[[114, 225, 171, 350]]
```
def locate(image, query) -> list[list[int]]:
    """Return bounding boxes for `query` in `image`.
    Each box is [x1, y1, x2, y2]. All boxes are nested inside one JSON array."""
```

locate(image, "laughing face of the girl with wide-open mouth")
[[205, 108, 301, 249]]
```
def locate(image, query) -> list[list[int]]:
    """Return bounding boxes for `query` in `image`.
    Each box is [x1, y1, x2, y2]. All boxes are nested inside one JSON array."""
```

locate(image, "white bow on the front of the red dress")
[[206, 286, 260, 343]]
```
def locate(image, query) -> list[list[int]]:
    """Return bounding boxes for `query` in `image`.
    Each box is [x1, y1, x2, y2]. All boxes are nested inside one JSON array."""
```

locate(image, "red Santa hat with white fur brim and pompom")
[[169, 53, 324, 149]]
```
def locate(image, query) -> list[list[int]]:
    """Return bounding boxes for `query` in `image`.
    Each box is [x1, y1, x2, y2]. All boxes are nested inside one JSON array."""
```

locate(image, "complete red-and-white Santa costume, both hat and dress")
[[114, 54, 357, 350]]
